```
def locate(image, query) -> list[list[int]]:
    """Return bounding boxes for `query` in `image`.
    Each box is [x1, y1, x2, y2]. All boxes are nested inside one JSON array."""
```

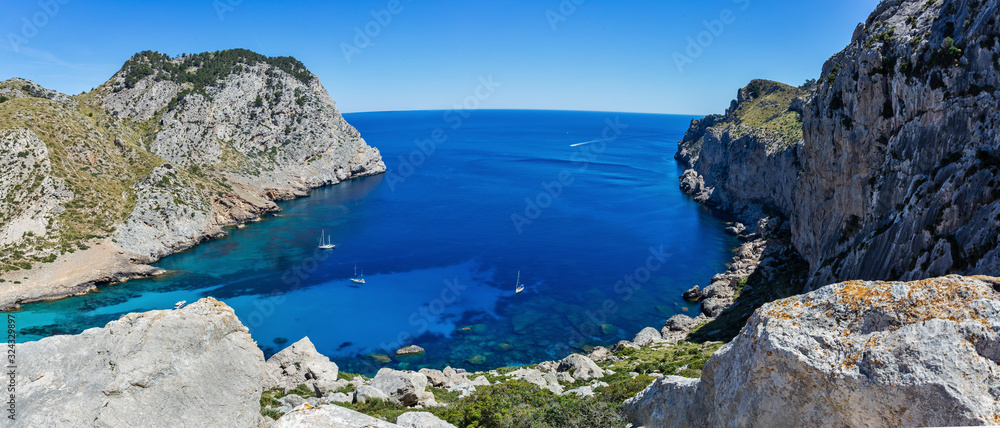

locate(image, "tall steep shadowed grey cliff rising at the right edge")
[[792, 0, 1000, 286]]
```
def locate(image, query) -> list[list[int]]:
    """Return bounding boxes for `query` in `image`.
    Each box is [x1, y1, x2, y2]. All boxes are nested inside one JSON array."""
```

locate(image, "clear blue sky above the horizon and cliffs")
[[0, 0, 878, 115]]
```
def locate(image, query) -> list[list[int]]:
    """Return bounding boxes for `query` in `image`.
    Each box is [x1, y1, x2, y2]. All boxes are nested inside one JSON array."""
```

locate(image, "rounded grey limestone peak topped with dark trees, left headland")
[[100, 50, 385, 189]]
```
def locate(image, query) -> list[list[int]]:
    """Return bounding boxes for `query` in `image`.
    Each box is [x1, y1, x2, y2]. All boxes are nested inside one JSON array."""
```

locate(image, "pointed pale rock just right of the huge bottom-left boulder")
[[264, 337, 347, 396]]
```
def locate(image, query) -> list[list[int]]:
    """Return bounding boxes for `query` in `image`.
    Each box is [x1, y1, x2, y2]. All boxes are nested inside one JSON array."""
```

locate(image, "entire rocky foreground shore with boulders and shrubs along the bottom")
[[13, 276, 1000, 427]]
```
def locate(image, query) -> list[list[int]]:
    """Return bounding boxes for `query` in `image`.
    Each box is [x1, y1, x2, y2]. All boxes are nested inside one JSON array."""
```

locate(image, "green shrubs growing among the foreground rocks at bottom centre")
[[260, 342, 722, 428]]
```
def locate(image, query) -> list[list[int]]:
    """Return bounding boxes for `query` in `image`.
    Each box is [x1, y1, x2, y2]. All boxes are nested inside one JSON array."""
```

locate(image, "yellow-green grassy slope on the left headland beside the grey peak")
[[0, 85, 163, 271]]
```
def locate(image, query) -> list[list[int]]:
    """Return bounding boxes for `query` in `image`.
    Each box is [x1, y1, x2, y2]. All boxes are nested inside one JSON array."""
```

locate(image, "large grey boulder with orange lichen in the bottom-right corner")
[[625, 276, 1000, 427]]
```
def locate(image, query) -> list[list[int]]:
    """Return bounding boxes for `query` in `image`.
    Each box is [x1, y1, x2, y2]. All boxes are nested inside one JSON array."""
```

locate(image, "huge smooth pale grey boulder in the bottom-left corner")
[[14, 298, 264, 427]]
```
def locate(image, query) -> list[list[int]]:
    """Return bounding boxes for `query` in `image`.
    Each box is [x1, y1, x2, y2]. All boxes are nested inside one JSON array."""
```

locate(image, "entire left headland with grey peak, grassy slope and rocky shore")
[[0, 50, 385, 308]]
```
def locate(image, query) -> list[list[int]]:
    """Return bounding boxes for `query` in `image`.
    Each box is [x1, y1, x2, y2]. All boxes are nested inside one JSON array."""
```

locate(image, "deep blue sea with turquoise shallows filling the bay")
[[14, 110, 737, 374]]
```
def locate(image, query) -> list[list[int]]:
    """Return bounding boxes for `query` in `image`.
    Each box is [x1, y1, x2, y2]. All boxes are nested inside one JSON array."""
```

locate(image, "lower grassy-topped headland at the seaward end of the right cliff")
[[675, 80, 807, 221]]
